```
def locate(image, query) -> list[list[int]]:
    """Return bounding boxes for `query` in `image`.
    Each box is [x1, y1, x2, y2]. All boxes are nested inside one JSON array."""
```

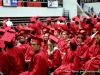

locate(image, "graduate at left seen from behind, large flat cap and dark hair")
[[1, 32, 25, 75]]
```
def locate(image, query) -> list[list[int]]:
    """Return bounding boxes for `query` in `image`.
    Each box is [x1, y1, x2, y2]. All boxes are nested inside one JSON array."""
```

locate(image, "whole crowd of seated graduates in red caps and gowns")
[[0, 14, 100, 75]]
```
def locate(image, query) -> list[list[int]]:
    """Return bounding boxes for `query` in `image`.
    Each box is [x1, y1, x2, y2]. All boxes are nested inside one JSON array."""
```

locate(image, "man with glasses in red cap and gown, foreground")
[[19, 36, 48, 75]]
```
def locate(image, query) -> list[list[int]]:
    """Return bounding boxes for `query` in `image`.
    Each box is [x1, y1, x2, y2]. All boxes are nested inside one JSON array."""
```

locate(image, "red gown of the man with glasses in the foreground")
[[19, 51, 48, 75]]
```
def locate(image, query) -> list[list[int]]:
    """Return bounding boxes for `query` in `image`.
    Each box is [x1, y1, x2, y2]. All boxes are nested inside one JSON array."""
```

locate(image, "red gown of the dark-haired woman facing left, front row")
[[54, 49, 79, 75]]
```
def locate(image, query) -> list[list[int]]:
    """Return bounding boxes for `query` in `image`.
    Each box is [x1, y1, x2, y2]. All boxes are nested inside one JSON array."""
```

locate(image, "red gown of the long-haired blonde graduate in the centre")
[[49, 49, 62, 70]]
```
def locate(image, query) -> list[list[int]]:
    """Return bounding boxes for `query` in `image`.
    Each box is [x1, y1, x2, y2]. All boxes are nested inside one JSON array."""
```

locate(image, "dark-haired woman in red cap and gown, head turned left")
[[54, 39, 80, 75]]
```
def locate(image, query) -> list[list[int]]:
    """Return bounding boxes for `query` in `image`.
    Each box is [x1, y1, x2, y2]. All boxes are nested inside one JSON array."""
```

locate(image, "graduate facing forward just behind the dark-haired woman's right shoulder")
[[77, 33, 89, 70]]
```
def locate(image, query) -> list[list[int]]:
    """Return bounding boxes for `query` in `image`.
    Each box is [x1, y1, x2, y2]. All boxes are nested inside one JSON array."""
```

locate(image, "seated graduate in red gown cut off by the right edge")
[[82, 33, 100, 75]]
